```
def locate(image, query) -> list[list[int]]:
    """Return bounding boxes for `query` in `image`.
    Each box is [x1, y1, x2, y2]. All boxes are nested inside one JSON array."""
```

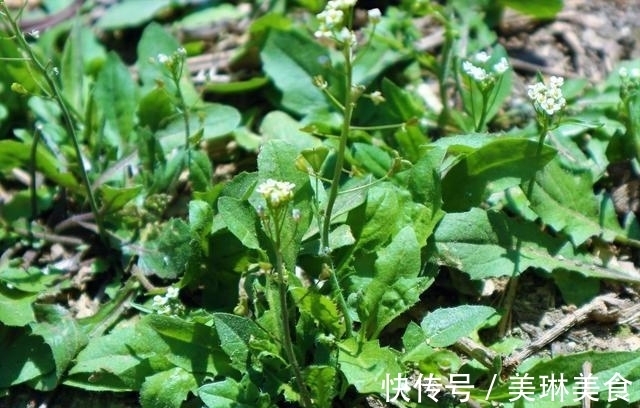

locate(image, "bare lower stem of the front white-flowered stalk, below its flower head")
[[275, 244, 313, 408]]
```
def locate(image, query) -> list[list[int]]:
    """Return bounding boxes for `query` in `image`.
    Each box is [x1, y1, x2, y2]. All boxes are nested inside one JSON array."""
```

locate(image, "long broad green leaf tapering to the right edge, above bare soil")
[[435, 208, 640, 282]]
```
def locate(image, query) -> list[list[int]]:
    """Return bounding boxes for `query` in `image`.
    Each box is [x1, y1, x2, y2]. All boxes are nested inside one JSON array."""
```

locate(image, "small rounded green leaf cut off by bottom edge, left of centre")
[[140, 367, 198, 408]]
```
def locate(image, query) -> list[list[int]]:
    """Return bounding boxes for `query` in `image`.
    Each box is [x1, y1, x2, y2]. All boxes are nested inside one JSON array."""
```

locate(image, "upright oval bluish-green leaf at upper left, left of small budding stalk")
[[94, 52, 137, 142]]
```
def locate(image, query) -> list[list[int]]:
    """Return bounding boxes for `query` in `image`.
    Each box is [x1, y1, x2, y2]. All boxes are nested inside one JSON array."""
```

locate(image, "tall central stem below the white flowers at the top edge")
[[320, 39, 355, 337]]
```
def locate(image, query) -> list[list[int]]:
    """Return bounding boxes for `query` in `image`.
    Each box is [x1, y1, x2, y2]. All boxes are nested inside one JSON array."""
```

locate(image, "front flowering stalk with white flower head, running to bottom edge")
[[256, 179, 313, 408]]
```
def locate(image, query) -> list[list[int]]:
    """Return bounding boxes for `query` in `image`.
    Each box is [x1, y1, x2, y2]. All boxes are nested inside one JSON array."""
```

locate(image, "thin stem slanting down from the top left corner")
[[0, 2, 109, 245]]
